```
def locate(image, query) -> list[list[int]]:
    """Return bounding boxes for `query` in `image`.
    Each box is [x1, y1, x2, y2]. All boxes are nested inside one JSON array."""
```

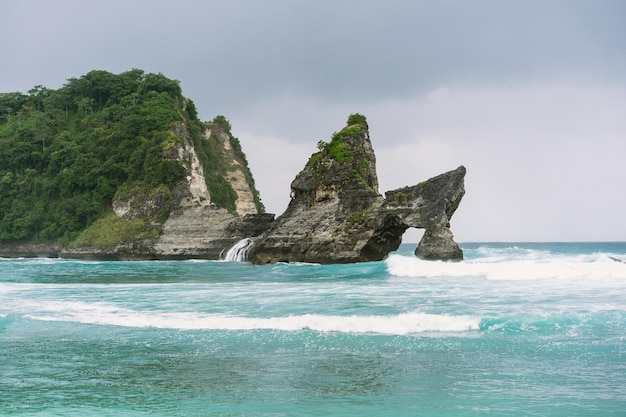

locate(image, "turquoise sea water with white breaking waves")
[[0, 243, 626, 417]]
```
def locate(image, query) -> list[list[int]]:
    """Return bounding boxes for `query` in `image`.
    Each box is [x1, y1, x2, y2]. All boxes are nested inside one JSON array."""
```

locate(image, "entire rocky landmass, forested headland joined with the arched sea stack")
[[0, 69, 465, 264]]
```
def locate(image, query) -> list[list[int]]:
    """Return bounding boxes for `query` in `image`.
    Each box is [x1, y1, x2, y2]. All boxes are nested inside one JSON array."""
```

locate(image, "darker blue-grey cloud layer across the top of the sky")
[[0, 0, 626, 114]]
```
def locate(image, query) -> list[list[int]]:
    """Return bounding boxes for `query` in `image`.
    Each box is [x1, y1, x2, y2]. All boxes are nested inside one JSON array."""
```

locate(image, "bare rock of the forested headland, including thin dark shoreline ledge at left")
[[61, 119, 274, 259]]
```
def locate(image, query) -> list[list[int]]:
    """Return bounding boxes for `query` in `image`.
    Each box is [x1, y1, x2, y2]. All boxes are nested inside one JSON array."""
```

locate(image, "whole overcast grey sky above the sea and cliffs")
[[0, 0, 626, 242]]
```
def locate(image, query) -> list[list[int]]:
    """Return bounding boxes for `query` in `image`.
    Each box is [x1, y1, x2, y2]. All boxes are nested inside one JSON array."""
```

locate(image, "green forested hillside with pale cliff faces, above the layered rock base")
[[0, 69, 264, 248]]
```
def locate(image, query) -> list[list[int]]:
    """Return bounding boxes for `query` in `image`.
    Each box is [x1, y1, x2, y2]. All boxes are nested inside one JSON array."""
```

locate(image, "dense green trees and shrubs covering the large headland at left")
[[0, 69, 260, 246]]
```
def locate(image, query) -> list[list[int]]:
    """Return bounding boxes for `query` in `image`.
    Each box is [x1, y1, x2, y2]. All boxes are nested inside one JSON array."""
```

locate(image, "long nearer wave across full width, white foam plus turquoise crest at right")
[[20, 302, 626, 340]]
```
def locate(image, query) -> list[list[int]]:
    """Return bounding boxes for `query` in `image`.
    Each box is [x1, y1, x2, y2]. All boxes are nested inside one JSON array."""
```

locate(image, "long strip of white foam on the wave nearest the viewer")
[[24, 302, 480, 335]]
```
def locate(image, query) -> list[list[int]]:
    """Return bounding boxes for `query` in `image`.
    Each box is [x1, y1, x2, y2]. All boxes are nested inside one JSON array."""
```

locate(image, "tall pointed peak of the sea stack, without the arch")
[[250, 114, 383, 264]]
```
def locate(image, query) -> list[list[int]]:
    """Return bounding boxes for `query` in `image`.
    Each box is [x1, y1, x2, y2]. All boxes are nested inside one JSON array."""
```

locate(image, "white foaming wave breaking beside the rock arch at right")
[[385, 254, 626, 280]]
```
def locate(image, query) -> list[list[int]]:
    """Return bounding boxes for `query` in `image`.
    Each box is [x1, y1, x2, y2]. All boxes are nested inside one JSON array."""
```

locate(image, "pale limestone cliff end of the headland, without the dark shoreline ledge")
[[153, 123, 274, 259]]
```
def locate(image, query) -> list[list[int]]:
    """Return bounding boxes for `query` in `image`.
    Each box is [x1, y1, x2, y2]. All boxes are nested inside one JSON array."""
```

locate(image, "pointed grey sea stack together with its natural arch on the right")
[[249, 114, 465, 264]]
